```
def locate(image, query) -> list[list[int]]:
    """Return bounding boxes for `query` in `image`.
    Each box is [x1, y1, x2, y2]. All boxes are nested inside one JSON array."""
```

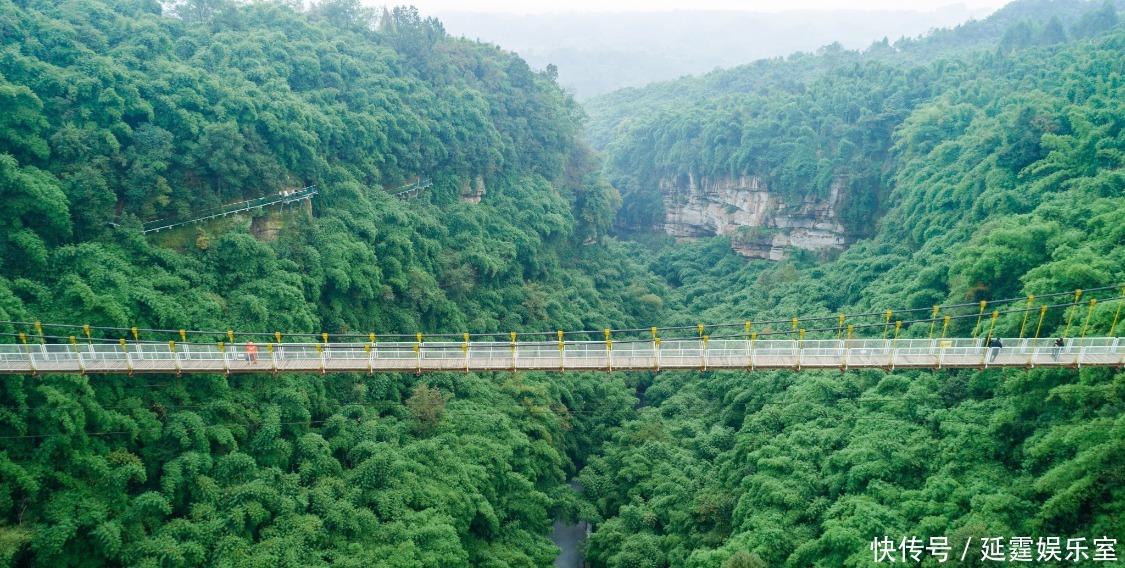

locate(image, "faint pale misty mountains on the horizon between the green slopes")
[[438, 4, 988, 99]]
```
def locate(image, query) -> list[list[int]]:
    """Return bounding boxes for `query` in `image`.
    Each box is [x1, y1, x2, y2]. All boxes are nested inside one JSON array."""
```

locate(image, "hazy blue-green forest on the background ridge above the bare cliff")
[[587, 0, 1117, 236]]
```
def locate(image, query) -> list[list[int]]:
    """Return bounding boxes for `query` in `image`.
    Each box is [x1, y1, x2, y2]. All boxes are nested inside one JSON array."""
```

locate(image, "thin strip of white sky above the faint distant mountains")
[[416, 0, 1008, 15]]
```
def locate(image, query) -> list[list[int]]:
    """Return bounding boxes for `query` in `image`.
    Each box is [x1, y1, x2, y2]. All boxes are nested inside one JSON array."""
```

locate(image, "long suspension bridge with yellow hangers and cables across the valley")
[[0, 287, 1125, 375]]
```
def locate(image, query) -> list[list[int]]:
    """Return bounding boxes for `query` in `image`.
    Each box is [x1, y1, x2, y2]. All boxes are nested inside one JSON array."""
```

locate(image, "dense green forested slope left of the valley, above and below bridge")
[[0, 0, 663, 567]]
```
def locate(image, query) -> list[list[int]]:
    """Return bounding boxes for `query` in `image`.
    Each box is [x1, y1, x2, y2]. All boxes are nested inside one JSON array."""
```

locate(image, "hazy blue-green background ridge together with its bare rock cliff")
[[586, 0, 1119, 263]]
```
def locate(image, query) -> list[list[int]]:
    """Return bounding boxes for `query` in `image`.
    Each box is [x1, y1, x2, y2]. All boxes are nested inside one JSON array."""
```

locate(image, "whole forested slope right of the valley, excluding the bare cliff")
[[581, 4, 1125, 568]]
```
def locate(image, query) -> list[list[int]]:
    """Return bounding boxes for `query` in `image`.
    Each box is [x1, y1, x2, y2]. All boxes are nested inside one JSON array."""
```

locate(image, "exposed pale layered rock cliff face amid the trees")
[[660, 175, 849, 261]]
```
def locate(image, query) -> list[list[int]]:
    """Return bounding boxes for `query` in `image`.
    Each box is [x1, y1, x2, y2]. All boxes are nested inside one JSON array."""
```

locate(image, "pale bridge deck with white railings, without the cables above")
[[0, 337, 1125, 373]]
